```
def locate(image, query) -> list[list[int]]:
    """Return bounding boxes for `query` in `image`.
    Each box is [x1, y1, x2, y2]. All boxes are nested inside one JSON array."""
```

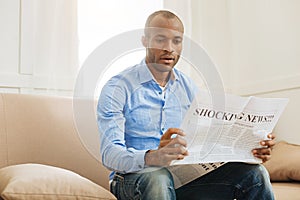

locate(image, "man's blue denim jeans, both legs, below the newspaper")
[[111, 163, 274, 200]]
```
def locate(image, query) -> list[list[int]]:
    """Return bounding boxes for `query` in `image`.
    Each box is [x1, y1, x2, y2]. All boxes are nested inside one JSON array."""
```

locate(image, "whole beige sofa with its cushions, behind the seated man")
[[0, 93, 300, 200]]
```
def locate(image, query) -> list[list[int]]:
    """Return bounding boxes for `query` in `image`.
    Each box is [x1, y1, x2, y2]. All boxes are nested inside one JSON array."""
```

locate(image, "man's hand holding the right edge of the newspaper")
[[252, 133, 275, 162]]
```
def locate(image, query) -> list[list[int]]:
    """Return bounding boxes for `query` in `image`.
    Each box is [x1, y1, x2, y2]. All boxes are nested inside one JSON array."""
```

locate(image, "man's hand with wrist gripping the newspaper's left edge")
[[145, 128, 188, 166]]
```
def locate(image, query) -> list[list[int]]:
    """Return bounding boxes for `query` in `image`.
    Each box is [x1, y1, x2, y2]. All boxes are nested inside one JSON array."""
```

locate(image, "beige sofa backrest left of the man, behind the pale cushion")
[[0, 93, 110, 189]]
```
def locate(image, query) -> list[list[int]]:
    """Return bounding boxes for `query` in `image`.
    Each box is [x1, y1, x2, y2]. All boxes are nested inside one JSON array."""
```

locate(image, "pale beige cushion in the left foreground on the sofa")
[[0, 164, 116, 200]]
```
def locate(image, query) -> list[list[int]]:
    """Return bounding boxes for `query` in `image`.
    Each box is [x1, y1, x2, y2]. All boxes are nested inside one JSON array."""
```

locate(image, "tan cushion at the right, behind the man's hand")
[[264, 141, 300, 181]]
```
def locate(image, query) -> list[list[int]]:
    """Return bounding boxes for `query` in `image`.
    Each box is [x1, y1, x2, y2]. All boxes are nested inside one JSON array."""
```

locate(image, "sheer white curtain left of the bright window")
[[20, 0, 78, 95]]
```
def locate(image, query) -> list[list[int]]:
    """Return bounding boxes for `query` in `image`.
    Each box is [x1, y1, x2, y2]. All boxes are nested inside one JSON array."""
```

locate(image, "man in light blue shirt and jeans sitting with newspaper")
[[98, 11, 274, 200]]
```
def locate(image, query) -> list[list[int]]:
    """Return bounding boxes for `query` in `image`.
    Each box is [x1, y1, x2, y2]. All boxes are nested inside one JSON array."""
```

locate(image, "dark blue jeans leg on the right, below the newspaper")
[[176, 163, 274, 200]]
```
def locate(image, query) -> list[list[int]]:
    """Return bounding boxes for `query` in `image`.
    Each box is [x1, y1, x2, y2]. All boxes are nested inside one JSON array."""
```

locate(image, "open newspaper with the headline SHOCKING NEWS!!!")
[[168, 92, 288, 188]]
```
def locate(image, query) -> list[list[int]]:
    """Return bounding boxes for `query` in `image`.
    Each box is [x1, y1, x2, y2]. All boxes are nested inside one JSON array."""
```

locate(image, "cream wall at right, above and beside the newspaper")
[[229, 0, 300, 144]]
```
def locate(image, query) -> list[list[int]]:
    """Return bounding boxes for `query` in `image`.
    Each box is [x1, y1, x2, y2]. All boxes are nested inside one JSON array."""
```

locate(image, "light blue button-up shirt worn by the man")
[[97, 60, 197, 177]]
